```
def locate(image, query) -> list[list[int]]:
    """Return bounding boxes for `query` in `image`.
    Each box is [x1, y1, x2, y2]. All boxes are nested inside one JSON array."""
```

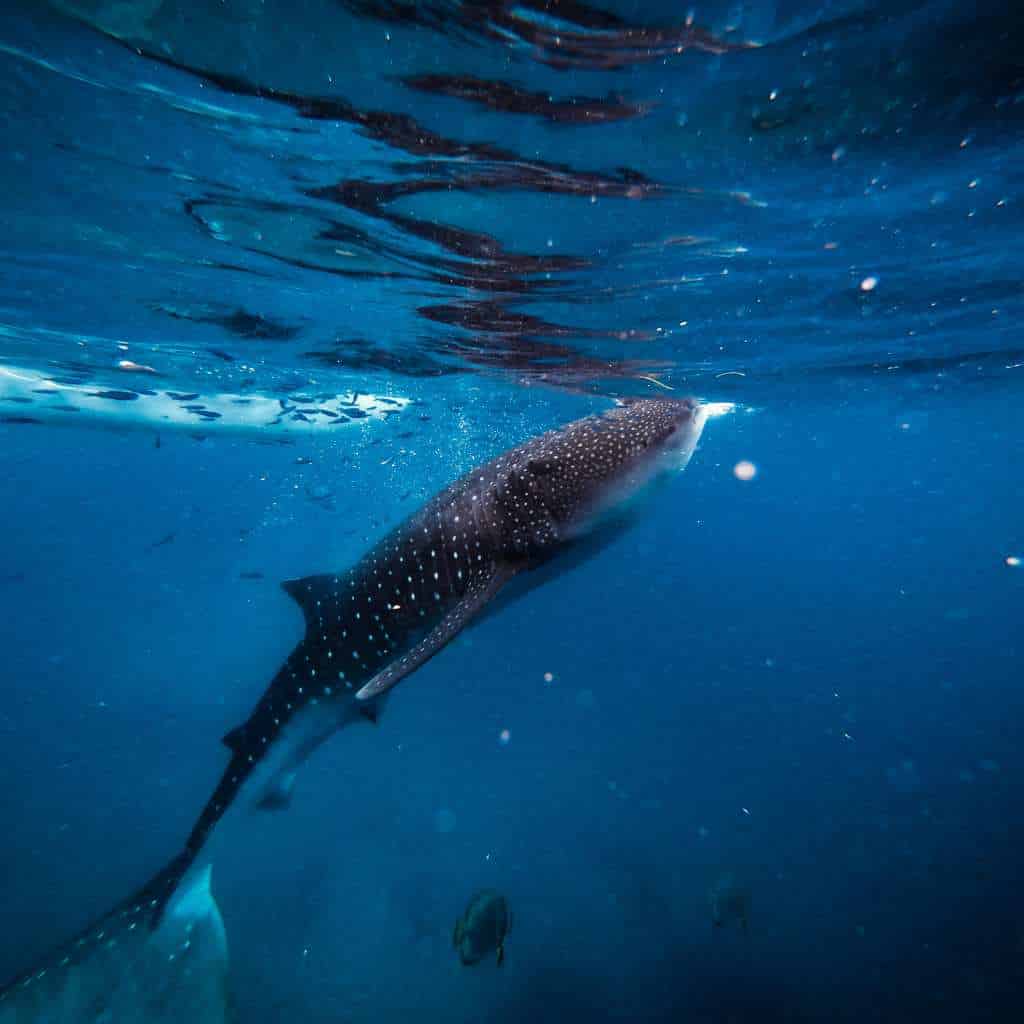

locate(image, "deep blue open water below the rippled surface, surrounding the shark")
[[2, 380, 1024, 1020]]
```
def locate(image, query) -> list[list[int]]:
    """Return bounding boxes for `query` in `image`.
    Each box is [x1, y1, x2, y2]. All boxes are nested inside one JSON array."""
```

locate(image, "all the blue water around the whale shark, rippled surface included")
[[0, 0, 1024, 1024]]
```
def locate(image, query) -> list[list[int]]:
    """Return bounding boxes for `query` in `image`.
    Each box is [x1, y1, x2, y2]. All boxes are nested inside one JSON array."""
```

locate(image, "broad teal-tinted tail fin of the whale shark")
[[0, 857, 229, 1024]]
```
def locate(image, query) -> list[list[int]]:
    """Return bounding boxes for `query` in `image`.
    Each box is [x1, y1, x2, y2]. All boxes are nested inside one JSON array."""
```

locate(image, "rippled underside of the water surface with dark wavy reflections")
[[0, 0, 1022, 405]]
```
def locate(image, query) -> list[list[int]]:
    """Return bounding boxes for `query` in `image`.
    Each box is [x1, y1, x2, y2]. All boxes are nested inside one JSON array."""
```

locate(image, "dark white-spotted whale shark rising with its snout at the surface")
[[0, 398, 725, 1020]]
